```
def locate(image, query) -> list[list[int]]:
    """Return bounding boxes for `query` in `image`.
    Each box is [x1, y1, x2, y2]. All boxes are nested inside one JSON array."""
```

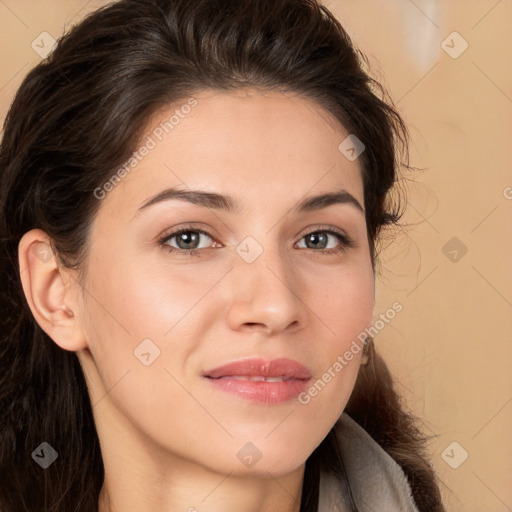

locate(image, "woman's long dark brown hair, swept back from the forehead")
[[0, 0, 444, 512]]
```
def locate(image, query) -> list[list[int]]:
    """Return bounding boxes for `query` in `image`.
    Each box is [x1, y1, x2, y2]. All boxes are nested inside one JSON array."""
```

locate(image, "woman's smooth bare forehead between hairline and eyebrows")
[[93, 90, 363, 218]]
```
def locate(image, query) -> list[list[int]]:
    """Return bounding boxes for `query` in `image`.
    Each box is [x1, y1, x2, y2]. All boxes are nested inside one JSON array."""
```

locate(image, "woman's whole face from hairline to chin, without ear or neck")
[[74, 91, 374, 475]]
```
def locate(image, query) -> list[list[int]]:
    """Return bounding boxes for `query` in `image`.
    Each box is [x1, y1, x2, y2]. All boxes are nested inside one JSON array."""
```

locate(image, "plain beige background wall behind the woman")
[[0, 0, 512, 512]]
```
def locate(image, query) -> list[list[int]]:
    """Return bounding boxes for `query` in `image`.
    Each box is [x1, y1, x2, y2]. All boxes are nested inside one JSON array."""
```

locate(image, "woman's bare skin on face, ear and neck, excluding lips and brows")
[[19, 90, 375, 512]]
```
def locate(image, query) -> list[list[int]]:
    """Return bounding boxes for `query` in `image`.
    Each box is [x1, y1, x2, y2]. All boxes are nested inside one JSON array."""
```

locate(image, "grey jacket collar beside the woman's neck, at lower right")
[[318, 413, 419, 512]]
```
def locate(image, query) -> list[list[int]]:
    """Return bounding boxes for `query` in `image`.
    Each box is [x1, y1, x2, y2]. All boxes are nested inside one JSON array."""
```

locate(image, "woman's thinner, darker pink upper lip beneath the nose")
[[205, 358, 311, 380]]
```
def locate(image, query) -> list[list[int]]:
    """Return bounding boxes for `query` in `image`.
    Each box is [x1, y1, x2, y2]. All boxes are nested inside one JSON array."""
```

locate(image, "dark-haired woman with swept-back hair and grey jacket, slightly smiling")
[[0, 0, 444, 512]]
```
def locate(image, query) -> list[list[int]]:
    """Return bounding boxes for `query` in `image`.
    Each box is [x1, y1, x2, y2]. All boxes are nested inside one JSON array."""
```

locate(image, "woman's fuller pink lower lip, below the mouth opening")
[[208, 377, 310, 404]]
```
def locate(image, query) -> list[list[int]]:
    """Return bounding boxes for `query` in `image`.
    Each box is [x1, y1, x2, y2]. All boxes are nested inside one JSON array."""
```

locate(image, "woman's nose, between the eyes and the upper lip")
[[223, 243, 309, 335]]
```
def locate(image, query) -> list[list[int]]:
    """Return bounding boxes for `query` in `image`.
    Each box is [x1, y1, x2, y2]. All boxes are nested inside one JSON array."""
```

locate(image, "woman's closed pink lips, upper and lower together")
[[204, 358, 311, 405]]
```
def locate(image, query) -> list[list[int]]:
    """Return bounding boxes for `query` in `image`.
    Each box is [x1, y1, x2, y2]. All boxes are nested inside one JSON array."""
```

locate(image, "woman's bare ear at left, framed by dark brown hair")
[[18, 229, 87, 352]]
